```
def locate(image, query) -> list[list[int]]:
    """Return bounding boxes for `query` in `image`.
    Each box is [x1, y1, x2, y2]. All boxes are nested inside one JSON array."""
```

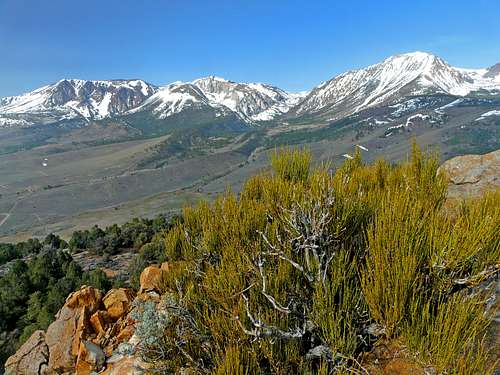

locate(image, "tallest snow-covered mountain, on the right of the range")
[[289, 52, 500, 119]]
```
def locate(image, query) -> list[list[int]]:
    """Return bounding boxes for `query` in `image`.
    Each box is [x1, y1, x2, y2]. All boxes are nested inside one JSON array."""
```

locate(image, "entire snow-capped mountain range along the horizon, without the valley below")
[[0, 52, 500, 127]]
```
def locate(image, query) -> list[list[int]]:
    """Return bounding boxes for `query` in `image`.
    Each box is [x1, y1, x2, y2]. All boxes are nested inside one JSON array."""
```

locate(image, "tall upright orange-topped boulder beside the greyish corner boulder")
[[45, 287, 102, 373]]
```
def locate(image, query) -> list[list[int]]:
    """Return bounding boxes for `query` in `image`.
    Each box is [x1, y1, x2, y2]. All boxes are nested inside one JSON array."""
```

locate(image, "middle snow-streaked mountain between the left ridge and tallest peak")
[[131, 76, 304, 122]]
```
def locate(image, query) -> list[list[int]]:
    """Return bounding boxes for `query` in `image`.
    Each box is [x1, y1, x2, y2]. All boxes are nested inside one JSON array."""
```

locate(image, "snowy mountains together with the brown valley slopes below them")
[[0, 52, 500, 241]]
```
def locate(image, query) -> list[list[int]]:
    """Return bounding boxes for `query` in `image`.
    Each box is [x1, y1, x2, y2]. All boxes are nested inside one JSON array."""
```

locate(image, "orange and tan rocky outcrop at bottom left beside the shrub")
[[6, 286, 141, 375]]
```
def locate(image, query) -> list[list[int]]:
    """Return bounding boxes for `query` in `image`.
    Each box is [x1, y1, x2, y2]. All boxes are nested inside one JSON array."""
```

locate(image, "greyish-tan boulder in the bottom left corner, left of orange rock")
[[5, 331, 49, 375]]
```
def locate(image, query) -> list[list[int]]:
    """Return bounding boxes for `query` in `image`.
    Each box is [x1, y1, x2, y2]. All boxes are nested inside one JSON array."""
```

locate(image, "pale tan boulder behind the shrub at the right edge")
[[439, 150, 500, 198]]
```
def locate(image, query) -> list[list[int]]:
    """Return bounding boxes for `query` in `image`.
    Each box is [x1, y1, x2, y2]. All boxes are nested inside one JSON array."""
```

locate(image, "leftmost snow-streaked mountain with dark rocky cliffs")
[[0, 79, 157, 125]]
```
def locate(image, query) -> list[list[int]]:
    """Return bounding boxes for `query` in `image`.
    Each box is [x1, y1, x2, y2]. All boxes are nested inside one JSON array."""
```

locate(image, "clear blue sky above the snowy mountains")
[[0, 0, 500, 96]]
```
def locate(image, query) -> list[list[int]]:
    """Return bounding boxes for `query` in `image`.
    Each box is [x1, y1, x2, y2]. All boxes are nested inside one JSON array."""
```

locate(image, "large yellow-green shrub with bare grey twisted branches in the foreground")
[[126, 145, 500, 374]]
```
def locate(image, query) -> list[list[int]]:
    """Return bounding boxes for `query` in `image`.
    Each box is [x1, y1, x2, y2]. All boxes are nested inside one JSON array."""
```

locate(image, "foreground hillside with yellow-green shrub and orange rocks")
[[6, 145, 500, 374]]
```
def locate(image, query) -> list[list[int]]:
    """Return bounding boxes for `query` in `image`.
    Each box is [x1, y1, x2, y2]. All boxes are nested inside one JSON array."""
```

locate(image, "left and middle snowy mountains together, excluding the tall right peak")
[[0, 76, 304, 126]]
